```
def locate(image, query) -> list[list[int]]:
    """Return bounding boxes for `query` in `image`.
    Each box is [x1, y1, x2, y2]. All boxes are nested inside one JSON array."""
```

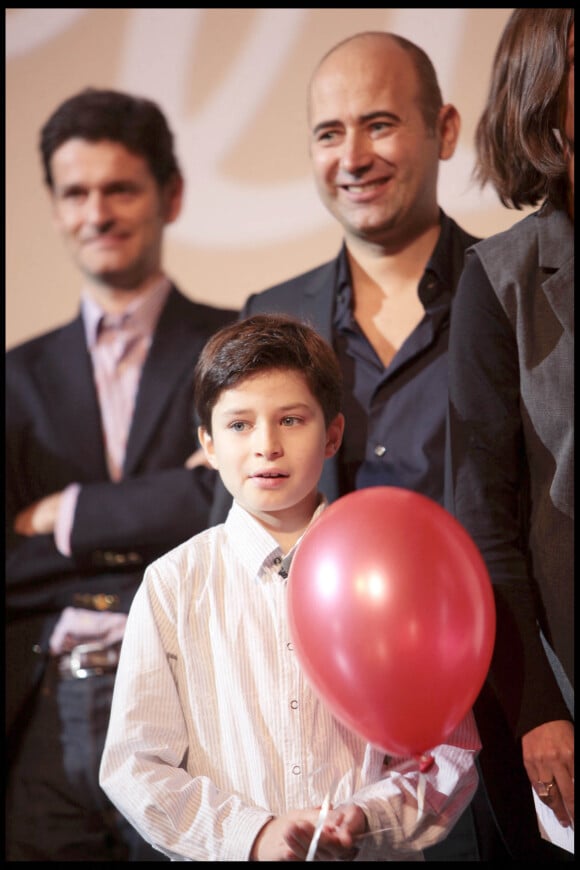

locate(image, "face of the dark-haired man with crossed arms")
[[51, 139, 181, 290]]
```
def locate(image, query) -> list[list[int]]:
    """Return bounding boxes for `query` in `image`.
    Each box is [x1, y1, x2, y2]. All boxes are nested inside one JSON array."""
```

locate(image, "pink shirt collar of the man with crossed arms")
[[81, 276, 171, 350]]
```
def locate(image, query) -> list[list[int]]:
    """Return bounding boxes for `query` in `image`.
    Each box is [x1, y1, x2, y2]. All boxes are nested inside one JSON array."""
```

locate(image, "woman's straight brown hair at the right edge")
[[474, 9, 574, 209]]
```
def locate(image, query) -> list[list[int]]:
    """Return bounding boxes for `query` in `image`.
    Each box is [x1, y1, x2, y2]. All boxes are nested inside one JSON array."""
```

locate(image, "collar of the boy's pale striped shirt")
[[225, 494, 328, 582]]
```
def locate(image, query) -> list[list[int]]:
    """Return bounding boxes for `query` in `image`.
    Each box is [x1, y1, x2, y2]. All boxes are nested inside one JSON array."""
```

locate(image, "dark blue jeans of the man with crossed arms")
[[6, 661, 169, 861]]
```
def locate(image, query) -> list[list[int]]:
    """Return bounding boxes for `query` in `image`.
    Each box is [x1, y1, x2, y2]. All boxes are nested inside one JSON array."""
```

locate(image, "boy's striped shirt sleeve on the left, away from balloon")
[[100, 567, 272, 861]]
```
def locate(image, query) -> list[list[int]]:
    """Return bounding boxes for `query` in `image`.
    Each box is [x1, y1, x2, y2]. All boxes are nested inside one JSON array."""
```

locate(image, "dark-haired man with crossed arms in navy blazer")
[[6, 88, 235, 861]]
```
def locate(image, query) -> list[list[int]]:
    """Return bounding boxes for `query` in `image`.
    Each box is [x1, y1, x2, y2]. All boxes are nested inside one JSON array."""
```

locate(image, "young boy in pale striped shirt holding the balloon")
[[101, 315, 479, 861]]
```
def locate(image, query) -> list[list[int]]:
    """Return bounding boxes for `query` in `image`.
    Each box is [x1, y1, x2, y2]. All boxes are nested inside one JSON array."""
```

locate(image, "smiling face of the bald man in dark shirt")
[[309, 37, 456, 245]]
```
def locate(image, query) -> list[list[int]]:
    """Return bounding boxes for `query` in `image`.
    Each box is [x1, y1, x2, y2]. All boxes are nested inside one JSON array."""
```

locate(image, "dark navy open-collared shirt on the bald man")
[[334, 213, 473, 504]]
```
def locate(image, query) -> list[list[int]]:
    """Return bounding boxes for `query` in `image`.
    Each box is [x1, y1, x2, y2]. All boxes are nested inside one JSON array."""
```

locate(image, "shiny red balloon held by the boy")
[[288, 486, 495, 757]]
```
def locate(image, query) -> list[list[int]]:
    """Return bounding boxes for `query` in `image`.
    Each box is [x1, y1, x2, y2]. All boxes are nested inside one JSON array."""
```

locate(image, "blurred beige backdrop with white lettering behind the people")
[[5, 9, 523, 347]]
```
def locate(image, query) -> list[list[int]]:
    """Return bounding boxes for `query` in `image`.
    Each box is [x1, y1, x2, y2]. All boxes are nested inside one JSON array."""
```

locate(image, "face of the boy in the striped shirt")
[[199, 369, 344, 531]]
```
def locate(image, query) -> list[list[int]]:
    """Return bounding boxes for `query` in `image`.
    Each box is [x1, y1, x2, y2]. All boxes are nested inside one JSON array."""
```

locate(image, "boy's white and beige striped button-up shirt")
[[100, 503, 480, 861]]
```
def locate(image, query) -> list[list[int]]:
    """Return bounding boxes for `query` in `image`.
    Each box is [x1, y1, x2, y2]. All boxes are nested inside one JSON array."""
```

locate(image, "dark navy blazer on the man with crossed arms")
[[6, 287, 237, 748]]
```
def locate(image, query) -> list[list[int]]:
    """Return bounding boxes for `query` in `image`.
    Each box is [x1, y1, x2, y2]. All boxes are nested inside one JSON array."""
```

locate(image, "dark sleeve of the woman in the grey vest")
[[445, 250, 567, 737]]
